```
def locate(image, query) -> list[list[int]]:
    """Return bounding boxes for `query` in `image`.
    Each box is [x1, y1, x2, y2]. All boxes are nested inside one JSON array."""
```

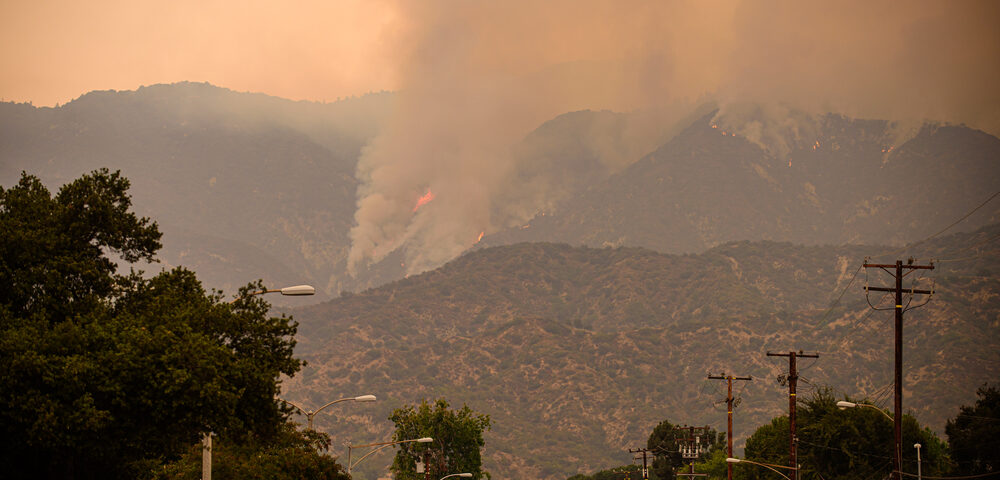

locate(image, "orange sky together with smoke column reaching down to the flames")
[[0, 0, 1000, 272]]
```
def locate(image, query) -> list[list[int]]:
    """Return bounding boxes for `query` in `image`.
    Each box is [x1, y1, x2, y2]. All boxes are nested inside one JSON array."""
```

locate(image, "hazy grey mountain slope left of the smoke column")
[[0, 83, 388, 295]]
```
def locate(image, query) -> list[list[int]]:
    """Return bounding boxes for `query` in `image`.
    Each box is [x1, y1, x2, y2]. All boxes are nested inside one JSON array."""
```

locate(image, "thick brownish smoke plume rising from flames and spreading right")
[[350, 0, 1000, 273]]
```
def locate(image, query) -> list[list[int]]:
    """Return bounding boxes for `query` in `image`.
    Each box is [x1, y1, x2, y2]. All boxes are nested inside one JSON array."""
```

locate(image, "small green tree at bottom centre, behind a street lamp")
[[389, 398, 492, 480]]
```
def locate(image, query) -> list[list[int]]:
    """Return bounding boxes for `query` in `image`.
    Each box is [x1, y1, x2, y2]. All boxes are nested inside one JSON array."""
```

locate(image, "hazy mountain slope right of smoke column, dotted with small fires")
[[482, 114, 1000, 253]]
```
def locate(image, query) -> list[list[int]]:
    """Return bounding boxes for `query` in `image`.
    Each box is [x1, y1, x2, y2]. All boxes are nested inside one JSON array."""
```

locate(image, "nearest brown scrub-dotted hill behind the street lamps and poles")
[[284, 226, 1000, 479]]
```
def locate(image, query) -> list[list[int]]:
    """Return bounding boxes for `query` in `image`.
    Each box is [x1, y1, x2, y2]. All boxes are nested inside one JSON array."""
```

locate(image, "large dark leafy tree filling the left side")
[[0, 170, 300, 479]]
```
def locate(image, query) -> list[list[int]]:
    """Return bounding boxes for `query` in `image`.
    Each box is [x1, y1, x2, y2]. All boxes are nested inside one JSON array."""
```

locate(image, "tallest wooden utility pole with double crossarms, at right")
[[864, 259, 934, 480]]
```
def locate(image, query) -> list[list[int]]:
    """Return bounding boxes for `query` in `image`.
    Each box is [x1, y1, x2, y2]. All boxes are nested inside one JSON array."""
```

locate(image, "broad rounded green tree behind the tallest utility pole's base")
[[739, 389, 949, 480]]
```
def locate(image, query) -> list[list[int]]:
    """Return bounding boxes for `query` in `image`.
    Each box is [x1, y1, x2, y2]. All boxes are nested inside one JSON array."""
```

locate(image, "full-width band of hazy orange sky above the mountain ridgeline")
[[0, 0, 1000, 131]]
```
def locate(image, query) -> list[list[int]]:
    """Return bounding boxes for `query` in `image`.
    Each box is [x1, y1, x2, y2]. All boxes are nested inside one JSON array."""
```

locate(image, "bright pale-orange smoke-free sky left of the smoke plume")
[[0, 0, 396, 106]]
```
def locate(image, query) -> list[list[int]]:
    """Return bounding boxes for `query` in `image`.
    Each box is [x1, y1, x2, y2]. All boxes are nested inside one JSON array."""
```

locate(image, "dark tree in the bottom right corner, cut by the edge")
[[944, 385, 1000, 475]]
